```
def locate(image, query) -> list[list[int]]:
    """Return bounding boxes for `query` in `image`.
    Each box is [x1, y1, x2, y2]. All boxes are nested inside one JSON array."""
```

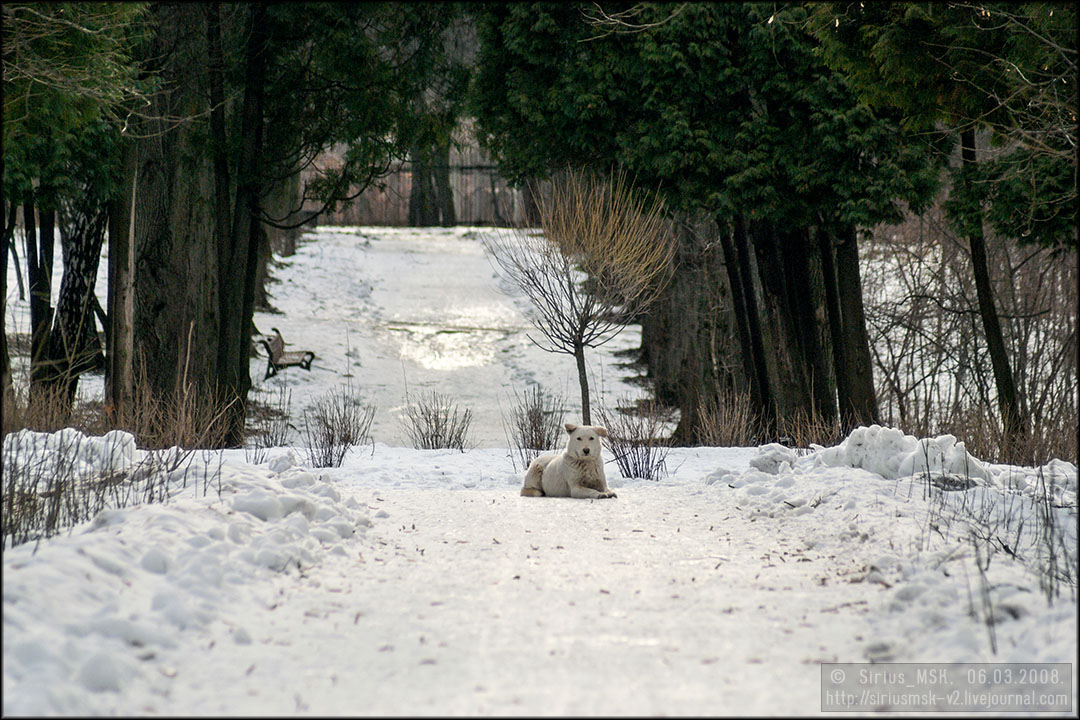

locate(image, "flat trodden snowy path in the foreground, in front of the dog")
[[130, 485, 881, 715]]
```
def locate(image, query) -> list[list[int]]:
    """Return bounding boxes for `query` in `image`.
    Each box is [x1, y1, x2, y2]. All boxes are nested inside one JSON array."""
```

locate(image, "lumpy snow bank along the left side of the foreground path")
[[3, 446, 370, 715]]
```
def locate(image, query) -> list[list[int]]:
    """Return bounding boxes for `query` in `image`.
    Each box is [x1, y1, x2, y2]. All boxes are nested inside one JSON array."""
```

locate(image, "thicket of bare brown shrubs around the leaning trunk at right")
[[860, 204, 1078, 464]]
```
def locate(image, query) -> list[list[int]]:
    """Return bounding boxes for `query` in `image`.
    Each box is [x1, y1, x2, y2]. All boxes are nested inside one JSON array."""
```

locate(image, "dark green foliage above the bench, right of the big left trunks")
[[264, 2, 468, 215]]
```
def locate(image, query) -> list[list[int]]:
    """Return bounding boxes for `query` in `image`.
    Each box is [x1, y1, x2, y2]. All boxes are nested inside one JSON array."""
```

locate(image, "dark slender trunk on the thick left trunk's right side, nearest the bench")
[[218, 3, 268, 446]]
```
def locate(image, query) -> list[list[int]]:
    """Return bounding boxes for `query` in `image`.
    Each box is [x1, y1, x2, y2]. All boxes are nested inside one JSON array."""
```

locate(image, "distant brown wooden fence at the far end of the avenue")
[[308, 140, 525, 226]]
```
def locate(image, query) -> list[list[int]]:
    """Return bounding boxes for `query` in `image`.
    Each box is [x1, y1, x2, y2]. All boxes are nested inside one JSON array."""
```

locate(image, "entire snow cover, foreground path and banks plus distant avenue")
[[2, 229, 1078, 716]]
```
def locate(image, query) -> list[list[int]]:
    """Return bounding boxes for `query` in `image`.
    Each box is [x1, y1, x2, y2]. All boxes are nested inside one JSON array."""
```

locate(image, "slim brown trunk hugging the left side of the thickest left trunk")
[[105, 142, 138, 419]]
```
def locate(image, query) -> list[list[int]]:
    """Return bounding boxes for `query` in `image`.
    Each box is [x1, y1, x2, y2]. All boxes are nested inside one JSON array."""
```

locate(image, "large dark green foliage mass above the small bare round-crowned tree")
[[472, 3, 937, 231]]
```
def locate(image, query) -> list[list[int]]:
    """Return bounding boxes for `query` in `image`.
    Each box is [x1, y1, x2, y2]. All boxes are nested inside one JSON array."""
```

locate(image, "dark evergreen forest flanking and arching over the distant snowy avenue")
[[0, 2, 1078, 463]]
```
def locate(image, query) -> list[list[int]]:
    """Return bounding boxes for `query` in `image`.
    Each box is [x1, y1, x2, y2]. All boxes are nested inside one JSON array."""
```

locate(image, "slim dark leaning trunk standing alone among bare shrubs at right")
[[960, 127, 1027, 460]]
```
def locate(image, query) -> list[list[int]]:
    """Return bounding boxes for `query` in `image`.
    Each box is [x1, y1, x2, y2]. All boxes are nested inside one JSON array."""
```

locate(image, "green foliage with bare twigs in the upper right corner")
[[810, 3, 1077, 246]]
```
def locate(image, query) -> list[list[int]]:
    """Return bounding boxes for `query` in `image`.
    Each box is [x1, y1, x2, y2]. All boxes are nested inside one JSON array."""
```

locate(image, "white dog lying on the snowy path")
[[522, 422, 616, 498]]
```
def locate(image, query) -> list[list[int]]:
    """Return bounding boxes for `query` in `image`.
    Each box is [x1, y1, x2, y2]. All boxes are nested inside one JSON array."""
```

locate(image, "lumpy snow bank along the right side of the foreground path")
[[703, 425, 1077, 662]]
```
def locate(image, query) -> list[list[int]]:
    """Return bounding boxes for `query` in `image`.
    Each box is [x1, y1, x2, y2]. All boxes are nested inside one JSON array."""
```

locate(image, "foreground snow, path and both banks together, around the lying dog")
[[3, 427, 1077, 715]]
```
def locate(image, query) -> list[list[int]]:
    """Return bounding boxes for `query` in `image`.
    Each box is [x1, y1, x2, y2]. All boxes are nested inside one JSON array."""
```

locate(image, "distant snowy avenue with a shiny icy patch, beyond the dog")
[[251, 227, 644, 447]]
